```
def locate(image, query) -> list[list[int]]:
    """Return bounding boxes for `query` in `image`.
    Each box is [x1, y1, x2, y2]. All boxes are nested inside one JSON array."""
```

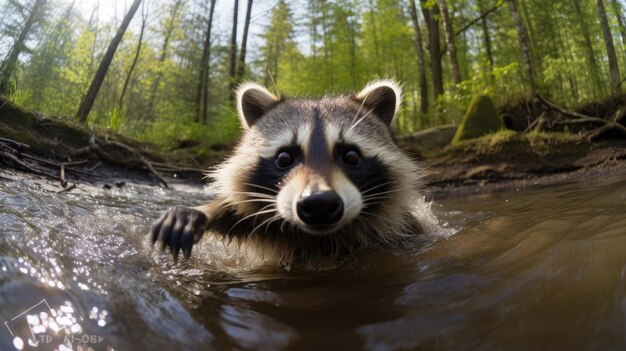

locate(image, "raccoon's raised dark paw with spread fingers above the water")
[[152, 206, 208, 260]]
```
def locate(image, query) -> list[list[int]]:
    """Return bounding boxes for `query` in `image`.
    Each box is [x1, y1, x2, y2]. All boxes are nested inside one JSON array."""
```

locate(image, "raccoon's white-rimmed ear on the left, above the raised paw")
[[235, 82, 280, 129]]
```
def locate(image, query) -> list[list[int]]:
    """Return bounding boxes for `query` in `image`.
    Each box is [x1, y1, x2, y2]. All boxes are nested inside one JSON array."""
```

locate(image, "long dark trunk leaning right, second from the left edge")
[[76, 0, 141, 123]]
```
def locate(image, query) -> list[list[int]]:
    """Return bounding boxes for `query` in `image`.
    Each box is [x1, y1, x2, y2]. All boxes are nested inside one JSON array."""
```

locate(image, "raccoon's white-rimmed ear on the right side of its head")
[[353, 79, 402, 125]]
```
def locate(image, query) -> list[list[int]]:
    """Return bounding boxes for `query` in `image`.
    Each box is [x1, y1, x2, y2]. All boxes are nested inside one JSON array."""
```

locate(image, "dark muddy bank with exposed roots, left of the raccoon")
[[0, 97, 219, 191]]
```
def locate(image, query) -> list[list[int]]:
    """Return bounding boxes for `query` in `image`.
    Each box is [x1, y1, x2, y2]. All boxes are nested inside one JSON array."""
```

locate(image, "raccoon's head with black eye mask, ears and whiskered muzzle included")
[[215, 80, 419, 242]]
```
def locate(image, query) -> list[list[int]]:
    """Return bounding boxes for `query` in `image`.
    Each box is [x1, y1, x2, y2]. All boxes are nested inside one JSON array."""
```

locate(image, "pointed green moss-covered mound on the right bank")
[[452, 95, 505, 144]]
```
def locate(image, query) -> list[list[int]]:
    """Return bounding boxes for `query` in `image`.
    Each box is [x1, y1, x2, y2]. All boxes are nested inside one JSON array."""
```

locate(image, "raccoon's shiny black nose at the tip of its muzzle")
[[296, 190, 343, 226]]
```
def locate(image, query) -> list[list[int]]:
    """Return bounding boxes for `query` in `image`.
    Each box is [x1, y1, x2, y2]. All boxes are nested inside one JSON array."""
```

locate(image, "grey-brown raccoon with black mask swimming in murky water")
[[152, 80, 424, 262]]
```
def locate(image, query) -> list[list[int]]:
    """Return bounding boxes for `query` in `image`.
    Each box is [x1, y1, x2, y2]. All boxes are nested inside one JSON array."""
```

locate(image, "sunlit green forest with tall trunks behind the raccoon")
[[0, 0, 626, 146]]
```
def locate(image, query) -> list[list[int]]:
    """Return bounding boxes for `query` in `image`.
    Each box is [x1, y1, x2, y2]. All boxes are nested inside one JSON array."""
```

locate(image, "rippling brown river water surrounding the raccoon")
[[0, 175, 626, 350]]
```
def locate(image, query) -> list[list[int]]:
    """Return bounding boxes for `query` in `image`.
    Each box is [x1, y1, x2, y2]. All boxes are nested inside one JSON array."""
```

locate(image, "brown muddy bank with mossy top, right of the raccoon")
[[421, 131, 626, 198]]
